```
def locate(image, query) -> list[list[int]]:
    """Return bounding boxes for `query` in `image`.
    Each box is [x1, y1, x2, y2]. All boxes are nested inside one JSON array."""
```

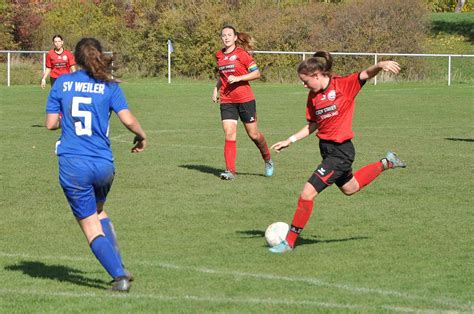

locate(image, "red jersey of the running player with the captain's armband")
[[216, 47, 258, 103]]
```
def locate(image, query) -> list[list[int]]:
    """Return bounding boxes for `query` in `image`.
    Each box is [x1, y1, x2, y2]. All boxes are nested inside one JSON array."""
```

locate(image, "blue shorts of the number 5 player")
[[59, 156, 115, 219]]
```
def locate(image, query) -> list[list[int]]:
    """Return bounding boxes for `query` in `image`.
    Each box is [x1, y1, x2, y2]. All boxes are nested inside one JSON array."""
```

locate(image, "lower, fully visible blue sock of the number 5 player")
[[90, 235, 126, 278]]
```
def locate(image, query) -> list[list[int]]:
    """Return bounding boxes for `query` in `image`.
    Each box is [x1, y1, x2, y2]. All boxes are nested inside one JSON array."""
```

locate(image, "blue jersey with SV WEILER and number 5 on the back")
[[46, 70, 128, 161]]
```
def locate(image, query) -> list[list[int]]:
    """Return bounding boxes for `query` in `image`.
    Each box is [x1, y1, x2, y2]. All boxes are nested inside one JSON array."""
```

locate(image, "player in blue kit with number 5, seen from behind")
[[45, 38, 147, 292]]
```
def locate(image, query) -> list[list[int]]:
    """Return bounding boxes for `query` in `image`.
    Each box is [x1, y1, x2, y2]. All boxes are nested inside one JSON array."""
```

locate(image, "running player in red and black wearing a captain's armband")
[[212, 26, 273, 180]]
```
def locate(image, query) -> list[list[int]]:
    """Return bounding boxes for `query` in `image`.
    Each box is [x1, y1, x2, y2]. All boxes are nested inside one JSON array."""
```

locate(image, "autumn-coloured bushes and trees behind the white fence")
[[0, 0, 470, 80]]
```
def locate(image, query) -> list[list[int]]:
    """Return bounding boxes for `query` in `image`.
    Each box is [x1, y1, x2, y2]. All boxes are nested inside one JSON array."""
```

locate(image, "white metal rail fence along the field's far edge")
[[0, 50, 474, 86]]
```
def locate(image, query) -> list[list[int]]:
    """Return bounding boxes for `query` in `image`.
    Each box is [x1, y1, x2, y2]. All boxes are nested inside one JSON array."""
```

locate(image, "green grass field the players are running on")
[[0, 80, 474, 313]]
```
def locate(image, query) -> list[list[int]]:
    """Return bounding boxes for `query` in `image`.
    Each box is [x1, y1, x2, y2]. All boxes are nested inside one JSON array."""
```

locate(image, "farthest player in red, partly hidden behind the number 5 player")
[[41, 35, 76, 89]]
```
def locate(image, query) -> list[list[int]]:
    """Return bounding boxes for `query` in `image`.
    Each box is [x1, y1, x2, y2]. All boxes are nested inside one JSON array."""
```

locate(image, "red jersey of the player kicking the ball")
[[306, 73, 365, 143]]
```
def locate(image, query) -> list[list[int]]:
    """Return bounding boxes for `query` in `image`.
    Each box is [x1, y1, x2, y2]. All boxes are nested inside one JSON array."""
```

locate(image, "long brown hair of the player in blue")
[[74, 38, 115, 82]]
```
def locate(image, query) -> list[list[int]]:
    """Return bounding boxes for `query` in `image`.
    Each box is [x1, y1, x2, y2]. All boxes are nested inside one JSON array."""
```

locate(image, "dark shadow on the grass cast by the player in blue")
[[5, 261, 108, 289]]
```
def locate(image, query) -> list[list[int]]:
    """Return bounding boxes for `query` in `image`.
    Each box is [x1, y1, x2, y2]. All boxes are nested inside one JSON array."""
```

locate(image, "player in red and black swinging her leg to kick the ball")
[[270, 51, 406, 253]]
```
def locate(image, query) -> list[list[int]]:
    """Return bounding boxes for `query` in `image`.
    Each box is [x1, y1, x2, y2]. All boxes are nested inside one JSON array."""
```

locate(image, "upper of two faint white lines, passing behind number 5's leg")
[[0, 252, 474, 311]]
